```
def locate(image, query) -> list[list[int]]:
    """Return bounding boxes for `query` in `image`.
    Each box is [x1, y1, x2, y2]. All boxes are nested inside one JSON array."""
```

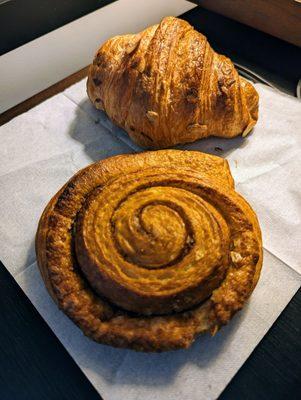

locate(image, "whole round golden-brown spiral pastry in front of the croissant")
[[36, 150, 262, 351]]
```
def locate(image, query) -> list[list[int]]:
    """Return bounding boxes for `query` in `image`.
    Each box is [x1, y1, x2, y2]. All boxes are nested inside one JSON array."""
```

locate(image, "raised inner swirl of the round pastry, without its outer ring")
[[75, 170, 229, 314]]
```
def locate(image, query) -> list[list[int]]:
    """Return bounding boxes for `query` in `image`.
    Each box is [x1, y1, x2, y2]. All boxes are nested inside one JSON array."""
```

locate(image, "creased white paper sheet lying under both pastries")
[[0, 81, 301, 400]]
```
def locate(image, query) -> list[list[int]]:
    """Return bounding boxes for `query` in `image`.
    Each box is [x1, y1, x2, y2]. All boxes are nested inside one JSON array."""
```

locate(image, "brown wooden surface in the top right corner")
[[194, 0, 301, 47]]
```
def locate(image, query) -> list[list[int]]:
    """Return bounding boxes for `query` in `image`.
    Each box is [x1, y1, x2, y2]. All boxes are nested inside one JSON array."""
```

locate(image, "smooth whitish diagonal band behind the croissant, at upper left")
[[0, 0, 195, 113]]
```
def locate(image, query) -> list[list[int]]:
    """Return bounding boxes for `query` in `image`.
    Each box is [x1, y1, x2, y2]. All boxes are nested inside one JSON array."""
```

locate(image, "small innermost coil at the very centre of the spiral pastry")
[[112, 202, 193, 269]]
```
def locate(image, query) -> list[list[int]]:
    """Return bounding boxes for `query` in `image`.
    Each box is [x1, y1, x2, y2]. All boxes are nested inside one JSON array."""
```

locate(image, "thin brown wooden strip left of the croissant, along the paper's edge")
[[0, 67, 89, 126]]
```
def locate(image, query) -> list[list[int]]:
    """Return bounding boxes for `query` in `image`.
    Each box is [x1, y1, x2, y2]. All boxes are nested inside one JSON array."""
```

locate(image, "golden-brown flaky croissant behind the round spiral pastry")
[[87, 17, 258, 148]]
